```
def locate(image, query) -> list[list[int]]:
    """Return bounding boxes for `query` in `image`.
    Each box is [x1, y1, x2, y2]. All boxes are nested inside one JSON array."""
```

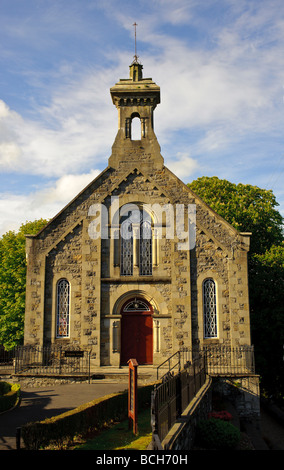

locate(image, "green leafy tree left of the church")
[[0, 219, 47, 350]]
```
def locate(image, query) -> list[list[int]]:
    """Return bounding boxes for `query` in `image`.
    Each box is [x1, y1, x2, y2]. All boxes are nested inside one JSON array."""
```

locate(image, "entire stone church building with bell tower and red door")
[[24, 58, 250, 367]]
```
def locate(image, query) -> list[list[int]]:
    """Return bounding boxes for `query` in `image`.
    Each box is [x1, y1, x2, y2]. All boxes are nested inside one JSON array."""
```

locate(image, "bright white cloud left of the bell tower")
[[0, 63, 120, 177]]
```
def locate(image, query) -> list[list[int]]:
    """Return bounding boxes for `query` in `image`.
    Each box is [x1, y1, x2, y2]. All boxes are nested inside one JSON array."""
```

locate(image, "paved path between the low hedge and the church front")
[[0, 381, 127, 450]]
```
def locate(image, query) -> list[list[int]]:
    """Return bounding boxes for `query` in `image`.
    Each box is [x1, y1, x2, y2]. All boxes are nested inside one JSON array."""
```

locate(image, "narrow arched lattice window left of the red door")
[[56, 279, 70, 338]]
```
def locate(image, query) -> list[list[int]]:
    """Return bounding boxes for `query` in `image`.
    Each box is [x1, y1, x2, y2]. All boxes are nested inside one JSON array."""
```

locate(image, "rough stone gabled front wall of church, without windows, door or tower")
[[25, 162, 250, 366]]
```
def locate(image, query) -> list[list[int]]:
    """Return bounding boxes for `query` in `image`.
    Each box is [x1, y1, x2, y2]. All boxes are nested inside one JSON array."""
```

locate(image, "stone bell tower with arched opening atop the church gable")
[[109, 54, 164, 168]]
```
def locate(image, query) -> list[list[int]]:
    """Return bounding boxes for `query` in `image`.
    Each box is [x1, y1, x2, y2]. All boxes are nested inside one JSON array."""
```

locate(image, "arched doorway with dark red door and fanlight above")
[[120, 297, 153, 365]]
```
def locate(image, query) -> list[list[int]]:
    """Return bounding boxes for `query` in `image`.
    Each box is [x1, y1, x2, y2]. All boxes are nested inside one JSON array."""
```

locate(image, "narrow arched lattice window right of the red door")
[[203, 279, 217, 338]]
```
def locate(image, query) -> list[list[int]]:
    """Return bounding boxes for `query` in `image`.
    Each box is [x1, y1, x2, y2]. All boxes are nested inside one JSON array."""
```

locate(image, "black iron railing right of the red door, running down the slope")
[[151, 346, 255, 442]]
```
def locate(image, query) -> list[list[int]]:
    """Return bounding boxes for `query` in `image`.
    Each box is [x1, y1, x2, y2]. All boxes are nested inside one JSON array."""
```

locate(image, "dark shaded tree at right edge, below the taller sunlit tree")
[[250, 244, 284, 399]]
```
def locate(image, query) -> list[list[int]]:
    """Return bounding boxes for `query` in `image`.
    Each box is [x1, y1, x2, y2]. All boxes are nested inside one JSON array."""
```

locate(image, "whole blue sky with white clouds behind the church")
[[0, 0, 284, 236]]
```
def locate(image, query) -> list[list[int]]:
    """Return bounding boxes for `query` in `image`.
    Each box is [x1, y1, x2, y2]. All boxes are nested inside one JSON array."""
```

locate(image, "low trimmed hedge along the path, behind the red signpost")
[[22, 385, 153, 450]]
